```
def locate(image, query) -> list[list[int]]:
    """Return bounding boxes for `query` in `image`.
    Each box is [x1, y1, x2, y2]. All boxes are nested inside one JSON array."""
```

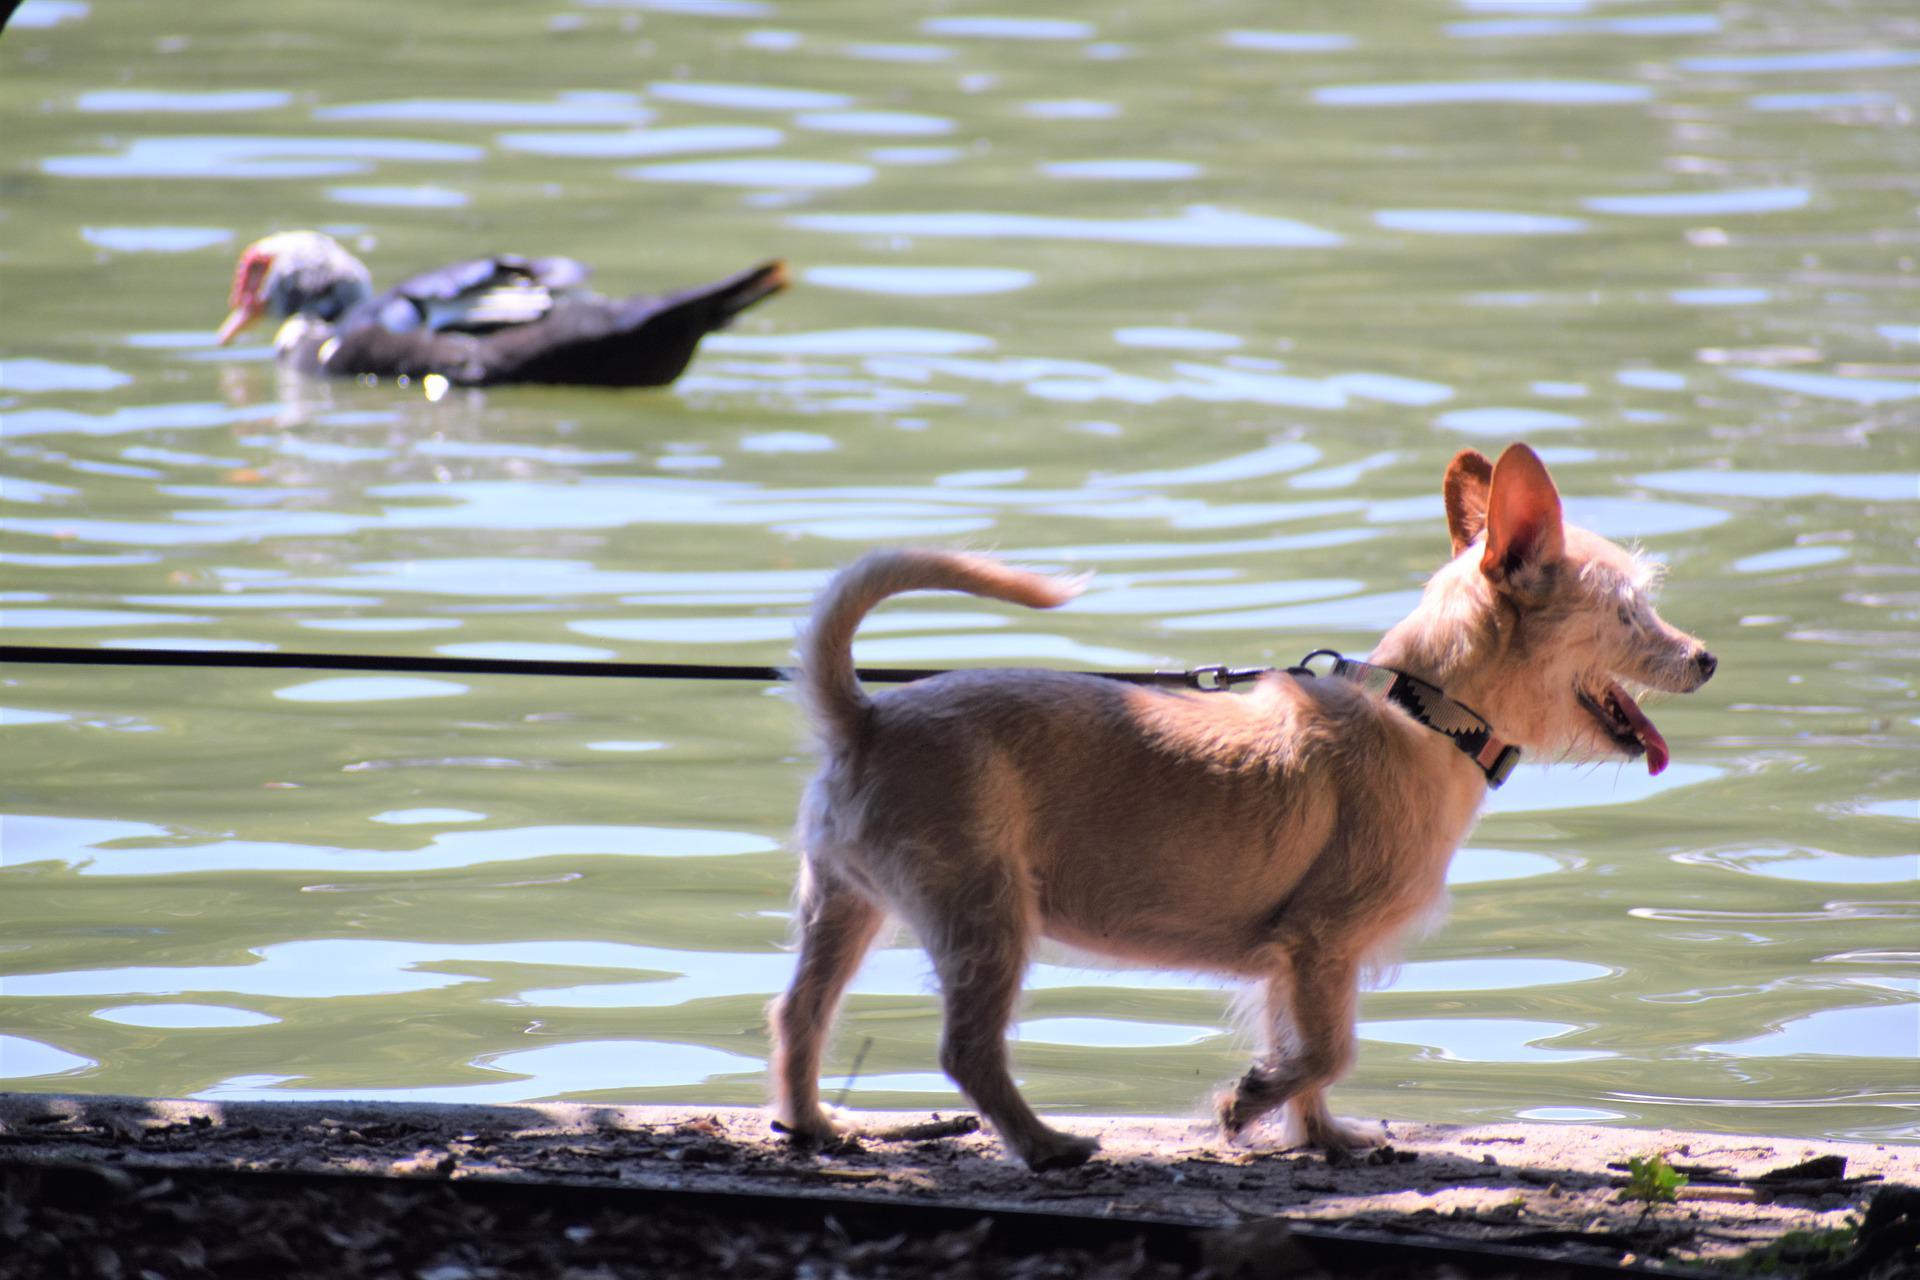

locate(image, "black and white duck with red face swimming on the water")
[[215, 230, 787, 388]]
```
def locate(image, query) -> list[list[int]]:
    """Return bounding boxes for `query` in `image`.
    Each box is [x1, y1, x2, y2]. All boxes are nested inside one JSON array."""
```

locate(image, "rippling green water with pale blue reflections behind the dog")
[[0, 0, 1920, 1140]]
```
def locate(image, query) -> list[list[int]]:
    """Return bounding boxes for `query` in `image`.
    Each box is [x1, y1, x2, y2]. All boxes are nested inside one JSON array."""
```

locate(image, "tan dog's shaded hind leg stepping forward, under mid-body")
[[914, 856, 1100, 1171]]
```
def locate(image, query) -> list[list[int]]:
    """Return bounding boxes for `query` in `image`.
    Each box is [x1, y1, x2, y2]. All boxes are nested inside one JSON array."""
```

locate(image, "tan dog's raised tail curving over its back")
[[797, 551, 1087, 745]]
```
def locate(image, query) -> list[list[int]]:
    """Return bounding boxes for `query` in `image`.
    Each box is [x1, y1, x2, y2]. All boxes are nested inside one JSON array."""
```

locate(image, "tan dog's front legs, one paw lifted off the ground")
[[1219, 954, 1380, 1148]]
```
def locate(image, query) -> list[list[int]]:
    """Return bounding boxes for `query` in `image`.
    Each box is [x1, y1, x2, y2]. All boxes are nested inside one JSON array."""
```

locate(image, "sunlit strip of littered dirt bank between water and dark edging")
[[0, 1094, 1920, 1274]]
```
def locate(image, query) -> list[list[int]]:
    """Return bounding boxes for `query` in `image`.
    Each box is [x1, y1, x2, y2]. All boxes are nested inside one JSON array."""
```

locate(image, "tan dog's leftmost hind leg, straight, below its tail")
[[768, 865, 887, 1142]]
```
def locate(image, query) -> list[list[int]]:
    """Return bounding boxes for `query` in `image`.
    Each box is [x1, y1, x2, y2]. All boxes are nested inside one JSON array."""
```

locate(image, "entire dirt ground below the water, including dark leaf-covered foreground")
[[0, 1094, 1920, 1280]]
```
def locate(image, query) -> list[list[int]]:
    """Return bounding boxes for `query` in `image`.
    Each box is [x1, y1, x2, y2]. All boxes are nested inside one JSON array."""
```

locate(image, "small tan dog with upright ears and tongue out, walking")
[[772, 445, 1715, 1169]]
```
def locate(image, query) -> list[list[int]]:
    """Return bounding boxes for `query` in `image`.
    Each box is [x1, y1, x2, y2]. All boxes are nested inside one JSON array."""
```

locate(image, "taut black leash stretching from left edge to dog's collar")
[[0, 645, 1271, 691]]
